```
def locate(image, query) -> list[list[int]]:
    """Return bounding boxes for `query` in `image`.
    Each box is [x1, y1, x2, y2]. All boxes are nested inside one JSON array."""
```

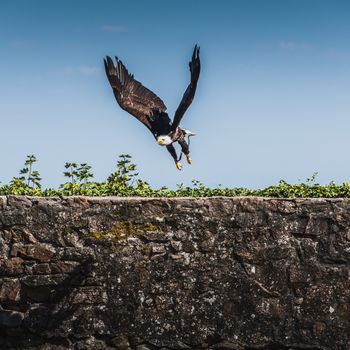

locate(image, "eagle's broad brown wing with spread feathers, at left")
[[104, 56, 166, 132]]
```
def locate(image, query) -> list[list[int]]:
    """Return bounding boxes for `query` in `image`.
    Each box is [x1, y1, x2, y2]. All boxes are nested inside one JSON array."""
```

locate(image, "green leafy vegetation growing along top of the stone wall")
[[0, 154, 350, 198]]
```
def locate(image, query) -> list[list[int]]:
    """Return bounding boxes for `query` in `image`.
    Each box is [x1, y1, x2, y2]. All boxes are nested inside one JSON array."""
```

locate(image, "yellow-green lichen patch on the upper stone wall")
[[91, 221, 161, 241]]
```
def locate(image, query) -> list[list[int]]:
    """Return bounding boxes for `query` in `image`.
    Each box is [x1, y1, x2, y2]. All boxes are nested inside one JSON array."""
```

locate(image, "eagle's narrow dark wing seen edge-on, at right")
[[172, 45, 201, 130]]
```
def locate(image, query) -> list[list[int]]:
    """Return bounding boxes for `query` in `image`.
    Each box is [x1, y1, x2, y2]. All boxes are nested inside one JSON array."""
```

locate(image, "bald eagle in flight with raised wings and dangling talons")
[[104, 45, 200, 170]]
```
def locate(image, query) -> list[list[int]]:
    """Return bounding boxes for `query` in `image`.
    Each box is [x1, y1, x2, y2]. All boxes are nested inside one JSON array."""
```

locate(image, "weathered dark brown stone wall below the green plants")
[[0, 196, 350, 350]]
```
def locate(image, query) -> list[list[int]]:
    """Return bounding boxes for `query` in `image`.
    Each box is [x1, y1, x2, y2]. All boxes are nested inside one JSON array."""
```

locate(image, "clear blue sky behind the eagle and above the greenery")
[[0, 0, 350, 188]]
